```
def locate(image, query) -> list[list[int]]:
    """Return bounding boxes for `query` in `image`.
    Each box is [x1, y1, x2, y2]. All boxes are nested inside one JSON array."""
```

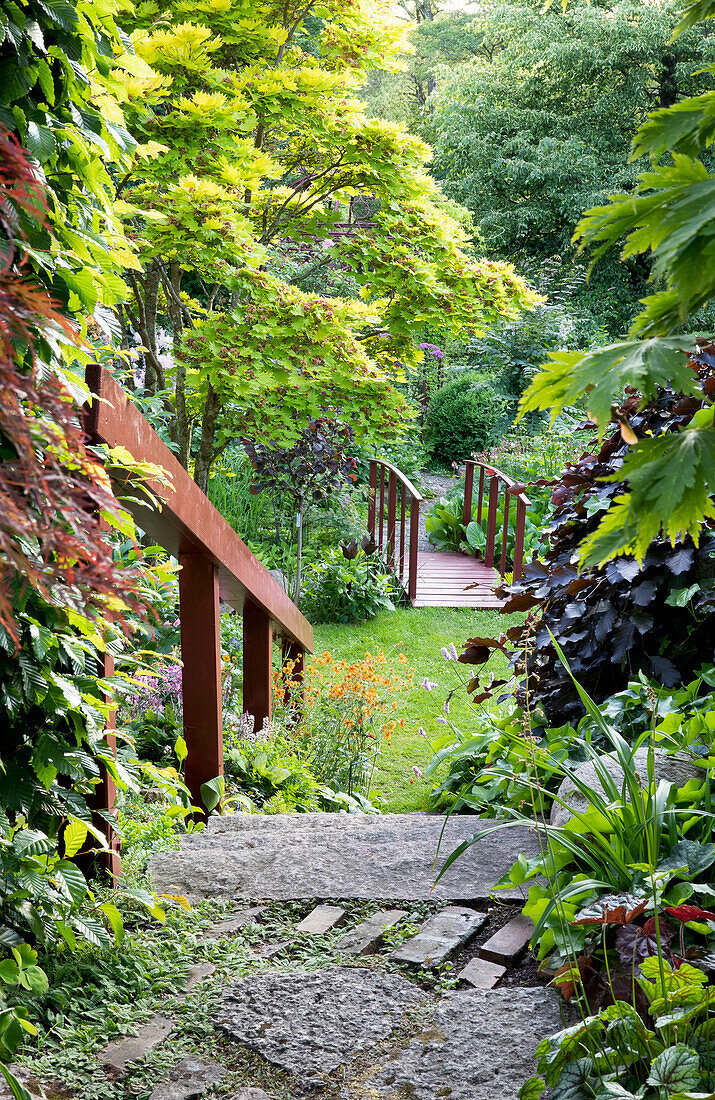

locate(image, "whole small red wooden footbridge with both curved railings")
[[367, 459, 530, 609]]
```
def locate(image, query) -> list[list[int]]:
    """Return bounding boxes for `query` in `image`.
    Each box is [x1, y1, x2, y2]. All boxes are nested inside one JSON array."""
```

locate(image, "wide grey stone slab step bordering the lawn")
[[150, 813, 538, 901]]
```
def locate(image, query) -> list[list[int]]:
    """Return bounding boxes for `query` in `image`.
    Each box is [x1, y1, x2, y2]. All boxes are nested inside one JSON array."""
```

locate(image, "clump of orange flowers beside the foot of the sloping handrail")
[[275, 650, 414, 798]]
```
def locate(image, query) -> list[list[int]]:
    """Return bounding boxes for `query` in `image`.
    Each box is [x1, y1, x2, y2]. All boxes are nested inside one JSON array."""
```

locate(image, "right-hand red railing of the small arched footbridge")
[[462, 459, 531, 581]]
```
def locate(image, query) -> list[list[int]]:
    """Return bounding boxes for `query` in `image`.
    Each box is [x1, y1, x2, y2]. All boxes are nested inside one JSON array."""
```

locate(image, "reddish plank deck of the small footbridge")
[[414, 550, 503, 609]]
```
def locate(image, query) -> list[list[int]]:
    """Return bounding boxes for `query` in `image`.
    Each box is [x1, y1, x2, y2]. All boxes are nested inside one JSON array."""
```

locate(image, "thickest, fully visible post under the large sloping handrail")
[[179, 553, 223, 806]]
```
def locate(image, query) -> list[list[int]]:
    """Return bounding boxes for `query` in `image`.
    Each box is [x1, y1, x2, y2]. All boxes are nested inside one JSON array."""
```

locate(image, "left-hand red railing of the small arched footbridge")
[[367, 459, 425, 603]]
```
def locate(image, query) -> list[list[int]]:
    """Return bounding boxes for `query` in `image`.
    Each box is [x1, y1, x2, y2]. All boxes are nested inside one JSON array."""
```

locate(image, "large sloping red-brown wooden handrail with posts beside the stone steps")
[[85, 364, 312, 870]]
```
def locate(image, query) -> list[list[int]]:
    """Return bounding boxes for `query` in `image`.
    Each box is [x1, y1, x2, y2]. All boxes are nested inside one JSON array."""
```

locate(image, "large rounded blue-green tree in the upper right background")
[[422, 0, 715, 337]]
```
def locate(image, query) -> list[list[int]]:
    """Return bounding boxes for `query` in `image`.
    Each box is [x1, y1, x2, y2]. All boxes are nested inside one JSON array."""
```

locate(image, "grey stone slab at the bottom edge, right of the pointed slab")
[[341, 989, 563, 1100]]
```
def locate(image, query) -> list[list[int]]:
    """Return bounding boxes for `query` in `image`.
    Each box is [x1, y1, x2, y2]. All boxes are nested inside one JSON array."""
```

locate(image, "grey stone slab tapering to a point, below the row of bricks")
[[215, 967, 432, 1085]]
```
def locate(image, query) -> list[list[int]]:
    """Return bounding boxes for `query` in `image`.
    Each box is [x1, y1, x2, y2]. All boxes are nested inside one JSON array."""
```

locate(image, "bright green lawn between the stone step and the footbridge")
[[315, 607, 518, 813]]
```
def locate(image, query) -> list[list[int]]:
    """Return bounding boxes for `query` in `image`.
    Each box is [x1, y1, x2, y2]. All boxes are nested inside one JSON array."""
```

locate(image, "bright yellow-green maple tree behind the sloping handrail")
[[111, 0, 531, 487]]
